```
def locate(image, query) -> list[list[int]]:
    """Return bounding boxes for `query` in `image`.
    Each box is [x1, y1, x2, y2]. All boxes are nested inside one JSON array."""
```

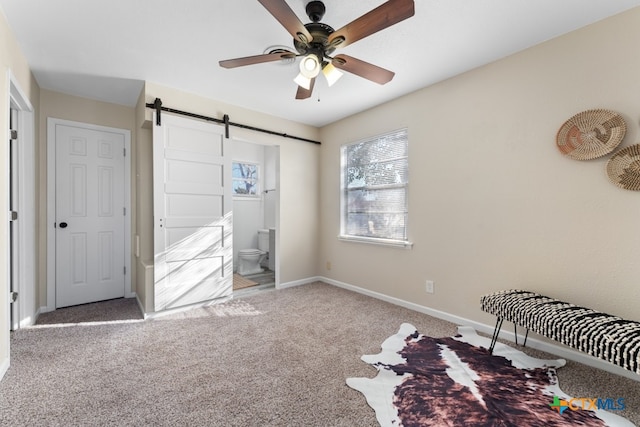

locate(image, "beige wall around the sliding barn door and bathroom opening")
[[136, 82, 320, 311]]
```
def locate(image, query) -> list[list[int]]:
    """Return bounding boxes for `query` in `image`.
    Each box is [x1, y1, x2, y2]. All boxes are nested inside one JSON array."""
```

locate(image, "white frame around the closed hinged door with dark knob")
[[43, 117, 135, 311]]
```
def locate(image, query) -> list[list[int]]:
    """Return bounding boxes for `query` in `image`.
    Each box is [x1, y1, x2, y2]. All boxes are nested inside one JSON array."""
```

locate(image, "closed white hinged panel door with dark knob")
[[55, 124, 126, 307]]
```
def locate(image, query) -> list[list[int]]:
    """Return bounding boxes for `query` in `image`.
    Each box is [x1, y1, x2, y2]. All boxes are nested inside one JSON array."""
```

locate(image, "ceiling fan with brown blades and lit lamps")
[[219, 0, 415, 99]]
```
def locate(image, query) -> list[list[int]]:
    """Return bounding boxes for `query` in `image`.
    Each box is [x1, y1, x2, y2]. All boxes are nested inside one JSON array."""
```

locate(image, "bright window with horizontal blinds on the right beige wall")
[[340, 129, 411, 246]]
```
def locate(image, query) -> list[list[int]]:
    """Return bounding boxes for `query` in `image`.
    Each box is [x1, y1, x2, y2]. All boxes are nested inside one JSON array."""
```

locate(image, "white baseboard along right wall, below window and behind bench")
[[320, 277, 640, 382]]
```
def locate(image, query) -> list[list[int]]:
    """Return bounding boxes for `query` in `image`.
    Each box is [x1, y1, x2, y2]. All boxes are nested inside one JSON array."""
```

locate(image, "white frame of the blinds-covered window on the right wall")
[[338, 128, 413, 249]]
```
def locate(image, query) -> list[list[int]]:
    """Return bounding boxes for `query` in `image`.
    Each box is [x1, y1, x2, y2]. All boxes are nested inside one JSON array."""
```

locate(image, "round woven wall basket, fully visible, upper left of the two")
[[556, 110, 627, 160]]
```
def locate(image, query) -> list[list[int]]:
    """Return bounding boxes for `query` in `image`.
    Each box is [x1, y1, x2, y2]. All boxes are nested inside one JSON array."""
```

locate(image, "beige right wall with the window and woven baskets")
[[318, 8, 640, 324]]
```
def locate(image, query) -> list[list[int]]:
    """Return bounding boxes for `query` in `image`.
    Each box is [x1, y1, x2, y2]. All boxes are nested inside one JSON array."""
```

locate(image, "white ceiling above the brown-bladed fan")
[[0, 0, 640, 126]]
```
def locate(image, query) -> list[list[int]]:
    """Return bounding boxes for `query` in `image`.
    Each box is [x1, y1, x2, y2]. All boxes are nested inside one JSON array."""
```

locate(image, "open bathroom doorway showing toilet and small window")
[[232, 139, 280, 294]]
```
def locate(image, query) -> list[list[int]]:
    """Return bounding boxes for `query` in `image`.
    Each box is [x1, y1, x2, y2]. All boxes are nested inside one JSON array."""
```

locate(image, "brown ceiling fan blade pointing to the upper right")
[[329, 0, 415, 47]]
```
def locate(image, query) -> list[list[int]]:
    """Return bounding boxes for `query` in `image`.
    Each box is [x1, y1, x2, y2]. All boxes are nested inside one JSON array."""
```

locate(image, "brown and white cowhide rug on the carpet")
[[347, 323, 633, 427]]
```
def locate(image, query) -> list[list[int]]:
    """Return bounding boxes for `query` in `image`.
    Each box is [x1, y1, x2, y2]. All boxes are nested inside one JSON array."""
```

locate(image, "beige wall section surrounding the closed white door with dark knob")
[[37, 89, 136, 308]]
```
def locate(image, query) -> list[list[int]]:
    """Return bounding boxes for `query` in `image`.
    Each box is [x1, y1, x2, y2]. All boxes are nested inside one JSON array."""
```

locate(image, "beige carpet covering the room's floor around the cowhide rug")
[[0, 283, 640, 427]]
